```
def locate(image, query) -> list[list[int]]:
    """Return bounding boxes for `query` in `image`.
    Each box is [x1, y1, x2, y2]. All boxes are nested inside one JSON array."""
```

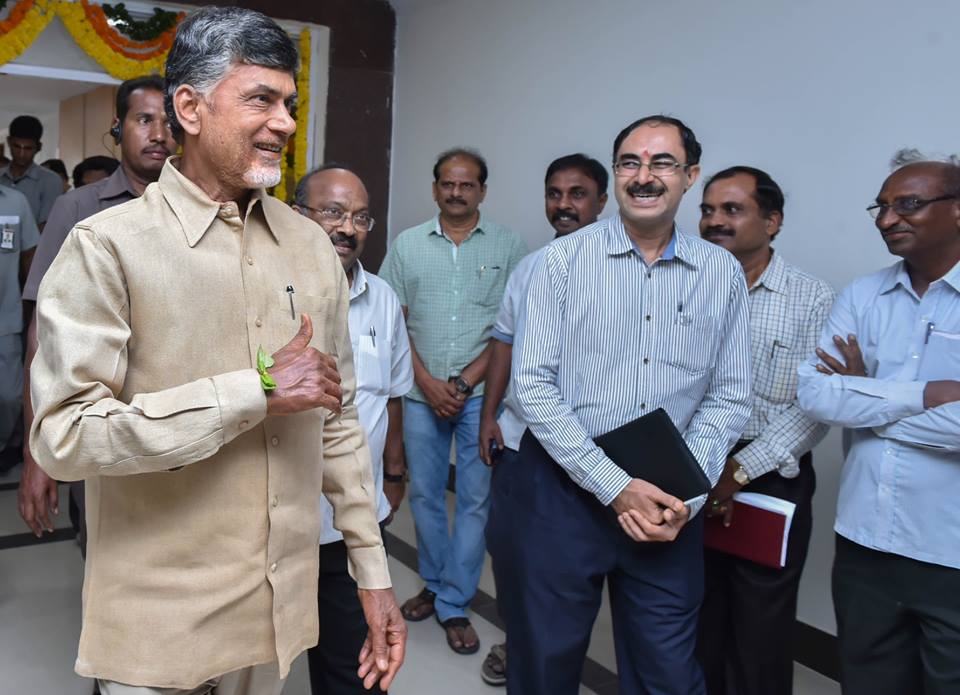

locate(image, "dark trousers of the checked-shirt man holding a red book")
[[697, 454, 816, 695]]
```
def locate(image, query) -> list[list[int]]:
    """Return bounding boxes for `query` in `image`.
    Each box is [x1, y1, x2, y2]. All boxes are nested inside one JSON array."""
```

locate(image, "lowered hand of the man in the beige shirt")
[[357, 589, 407, 690]]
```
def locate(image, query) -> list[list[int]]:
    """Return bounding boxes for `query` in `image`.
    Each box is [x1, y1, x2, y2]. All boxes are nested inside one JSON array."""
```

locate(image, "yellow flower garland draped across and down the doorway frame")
[[0, 0, 311, 198]]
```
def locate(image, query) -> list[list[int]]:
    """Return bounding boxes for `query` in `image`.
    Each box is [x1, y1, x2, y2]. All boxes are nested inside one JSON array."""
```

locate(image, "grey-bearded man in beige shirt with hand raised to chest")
[[31, 7, 406, 695]]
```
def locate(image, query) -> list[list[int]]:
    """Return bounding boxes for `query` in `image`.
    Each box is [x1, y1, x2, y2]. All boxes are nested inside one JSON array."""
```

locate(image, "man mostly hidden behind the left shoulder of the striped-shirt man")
[[479, 154, 608, 685]]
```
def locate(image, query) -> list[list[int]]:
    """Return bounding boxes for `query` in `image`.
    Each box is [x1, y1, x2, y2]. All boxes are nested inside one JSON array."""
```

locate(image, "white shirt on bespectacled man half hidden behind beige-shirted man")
[[320, 261, 413, 545]]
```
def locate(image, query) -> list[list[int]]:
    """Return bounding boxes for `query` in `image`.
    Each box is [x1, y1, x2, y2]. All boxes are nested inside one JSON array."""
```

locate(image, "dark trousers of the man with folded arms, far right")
[[833, 536, 960, 695]]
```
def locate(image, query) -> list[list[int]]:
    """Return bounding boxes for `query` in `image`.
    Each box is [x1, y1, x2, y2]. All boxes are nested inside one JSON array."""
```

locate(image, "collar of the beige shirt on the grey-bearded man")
[[157, 157, 272, 247]]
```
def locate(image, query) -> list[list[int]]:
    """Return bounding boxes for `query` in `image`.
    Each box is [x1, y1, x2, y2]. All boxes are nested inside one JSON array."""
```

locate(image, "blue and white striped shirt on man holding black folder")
[[513, 216, 751, 515]]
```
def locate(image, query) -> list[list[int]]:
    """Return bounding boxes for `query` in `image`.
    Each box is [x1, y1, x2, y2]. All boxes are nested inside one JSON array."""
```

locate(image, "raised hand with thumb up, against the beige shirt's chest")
[[267, 314, 343, 415]]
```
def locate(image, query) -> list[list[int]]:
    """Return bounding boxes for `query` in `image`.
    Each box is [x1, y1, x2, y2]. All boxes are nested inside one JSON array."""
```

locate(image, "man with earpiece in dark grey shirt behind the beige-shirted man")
[[17, 75, 177, 552]]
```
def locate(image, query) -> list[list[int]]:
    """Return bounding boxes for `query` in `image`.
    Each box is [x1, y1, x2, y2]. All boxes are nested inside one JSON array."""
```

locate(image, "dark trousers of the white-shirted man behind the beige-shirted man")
[[307, 541, 383, 695]]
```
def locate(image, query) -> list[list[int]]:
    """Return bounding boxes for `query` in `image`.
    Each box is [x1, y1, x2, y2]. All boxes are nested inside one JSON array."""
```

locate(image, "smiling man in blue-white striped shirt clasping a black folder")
[[499, 116, 751, 695]]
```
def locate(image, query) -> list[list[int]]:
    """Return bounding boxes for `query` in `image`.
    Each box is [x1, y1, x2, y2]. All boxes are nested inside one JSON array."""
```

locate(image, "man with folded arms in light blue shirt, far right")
[[799, 151, 960, 695]]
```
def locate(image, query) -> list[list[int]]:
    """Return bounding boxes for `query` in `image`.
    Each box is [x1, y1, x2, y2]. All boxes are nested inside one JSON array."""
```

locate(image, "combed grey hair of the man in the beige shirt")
[[164, 7, 299, 140]]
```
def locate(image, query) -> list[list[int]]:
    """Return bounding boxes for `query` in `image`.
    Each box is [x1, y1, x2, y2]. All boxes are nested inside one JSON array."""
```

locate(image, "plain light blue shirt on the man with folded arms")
[[799, 261, 960, 568]]
